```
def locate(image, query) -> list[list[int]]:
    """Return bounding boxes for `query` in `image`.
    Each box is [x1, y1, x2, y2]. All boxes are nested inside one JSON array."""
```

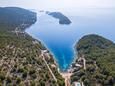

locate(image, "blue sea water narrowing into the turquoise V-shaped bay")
[[26, 9, 115, 70]]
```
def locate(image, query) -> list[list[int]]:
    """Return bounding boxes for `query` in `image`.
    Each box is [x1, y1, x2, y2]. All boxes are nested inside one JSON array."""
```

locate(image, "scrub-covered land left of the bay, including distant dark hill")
[[0, 7, 65, 86]]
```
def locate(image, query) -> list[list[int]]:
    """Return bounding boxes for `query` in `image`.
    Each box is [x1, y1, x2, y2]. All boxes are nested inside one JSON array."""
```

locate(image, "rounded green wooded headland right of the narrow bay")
[[71, 34, 115, 86]]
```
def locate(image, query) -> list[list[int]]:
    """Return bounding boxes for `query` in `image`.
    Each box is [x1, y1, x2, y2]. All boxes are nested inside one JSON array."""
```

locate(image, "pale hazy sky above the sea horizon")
[[0, 0, 115, 10]]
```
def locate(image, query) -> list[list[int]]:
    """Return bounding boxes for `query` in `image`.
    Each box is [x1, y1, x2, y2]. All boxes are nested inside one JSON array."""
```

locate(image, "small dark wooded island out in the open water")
[[46, 11, 72, 25]]
